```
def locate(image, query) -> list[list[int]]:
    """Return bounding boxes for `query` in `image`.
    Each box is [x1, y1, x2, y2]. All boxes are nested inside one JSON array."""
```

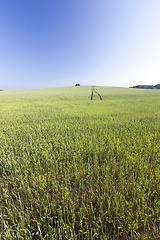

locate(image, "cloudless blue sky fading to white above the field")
[[0, 0, 160, 90]]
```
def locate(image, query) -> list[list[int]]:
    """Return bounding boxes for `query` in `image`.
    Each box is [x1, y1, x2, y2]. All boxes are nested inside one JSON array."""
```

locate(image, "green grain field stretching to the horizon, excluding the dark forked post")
[[0, 86, 160, 240]]
